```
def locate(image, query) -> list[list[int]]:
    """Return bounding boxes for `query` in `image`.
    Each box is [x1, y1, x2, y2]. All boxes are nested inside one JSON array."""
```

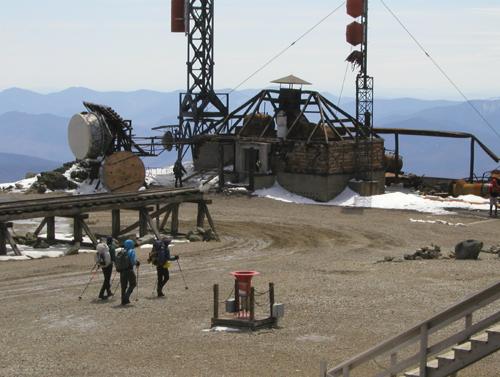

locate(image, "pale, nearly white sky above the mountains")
[[0, 0, 500, 99]]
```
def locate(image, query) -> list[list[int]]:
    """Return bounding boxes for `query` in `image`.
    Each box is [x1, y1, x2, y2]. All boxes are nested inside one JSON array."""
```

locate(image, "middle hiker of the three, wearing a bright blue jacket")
[[115, 240, 141, 305]]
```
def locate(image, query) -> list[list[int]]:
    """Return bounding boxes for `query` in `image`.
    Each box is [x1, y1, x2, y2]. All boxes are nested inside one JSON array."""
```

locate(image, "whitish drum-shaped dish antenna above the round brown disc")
[[68, 113, 112, 160]]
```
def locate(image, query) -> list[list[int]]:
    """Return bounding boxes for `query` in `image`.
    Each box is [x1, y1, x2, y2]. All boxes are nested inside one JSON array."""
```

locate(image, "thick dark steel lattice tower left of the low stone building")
[[179, 0, 229, 159]]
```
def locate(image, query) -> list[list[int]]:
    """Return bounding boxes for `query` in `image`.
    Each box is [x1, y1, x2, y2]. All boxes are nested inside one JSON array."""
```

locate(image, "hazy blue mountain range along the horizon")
[[0, 88, 500, 183]]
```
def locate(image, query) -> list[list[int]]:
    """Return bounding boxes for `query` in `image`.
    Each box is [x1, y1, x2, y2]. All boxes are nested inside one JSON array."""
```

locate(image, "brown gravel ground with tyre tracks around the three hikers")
[[0, 195, 500, 377]]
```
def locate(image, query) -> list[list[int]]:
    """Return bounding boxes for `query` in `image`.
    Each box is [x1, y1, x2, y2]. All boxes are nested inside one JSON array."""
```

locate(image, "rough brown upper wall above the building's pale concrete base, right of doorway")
[[284, 139, 384, 175]]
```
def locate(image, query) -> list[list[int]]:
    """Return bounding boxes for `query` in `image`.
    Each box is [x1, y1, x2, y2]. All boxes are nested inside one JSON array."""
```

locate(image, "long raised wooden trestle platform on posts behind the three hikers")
[[0, 188, 218, 255]]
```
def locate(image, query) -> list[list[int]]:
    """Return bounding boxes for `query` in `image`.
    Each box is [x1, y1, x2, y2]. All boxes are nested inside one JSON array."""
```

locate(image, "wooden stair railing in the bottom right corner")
[[320, 283, 500, 377]]
